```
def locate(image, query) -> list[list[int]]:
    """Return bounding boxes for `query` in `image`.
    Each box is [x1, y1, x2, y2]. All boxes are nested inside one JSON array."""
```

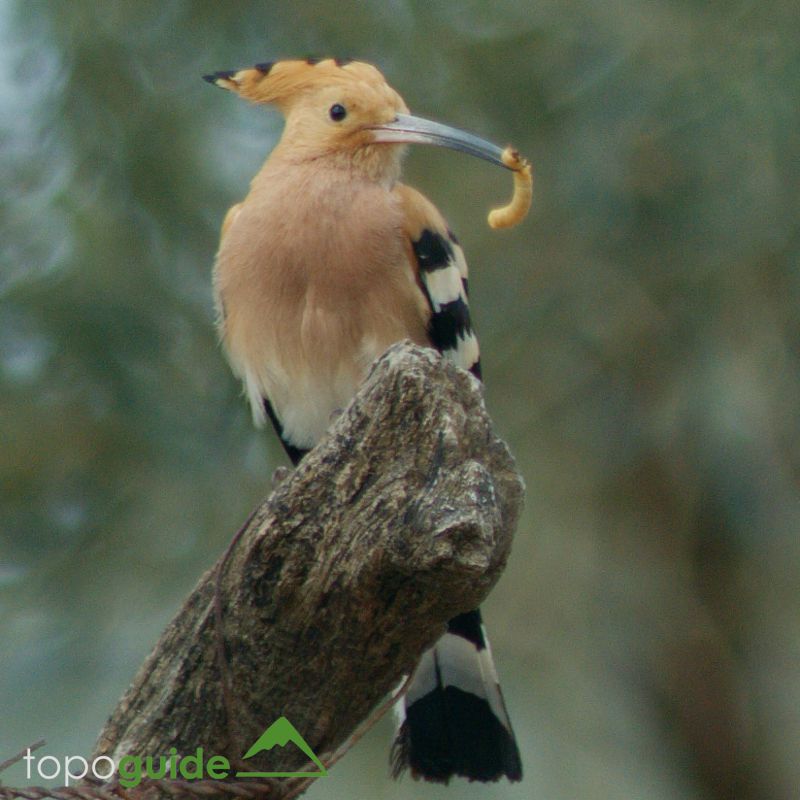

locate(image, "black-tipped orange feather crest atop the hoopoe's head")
[[204, 58, 388, 110]]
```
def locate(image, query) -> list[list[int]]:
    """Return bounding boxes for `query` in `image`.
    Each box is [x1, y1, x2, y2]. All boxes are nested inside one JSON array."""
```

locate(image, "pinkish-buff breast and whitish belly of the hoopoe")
[[215, 168, 428, 448]]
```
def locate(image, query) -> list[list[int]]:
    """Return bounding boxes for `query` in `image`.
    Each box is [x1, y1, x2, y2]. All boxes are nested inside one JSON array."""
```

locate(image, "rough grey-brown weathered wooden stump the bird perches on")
[[95, 343, 523, 770]]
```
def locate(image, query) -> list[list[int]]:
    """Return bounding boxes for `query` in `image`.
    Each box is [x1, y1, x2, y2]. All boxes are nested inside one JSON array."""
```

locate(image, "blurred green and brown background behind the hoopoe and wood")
[[0, 0, 800, 800]]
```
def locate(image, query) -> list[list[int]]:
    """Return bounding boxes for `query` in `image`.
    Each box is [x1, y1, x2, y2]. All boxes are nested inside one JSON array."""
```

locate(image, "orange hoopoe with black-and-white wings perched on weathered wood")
[[205, 59, 530, 783]]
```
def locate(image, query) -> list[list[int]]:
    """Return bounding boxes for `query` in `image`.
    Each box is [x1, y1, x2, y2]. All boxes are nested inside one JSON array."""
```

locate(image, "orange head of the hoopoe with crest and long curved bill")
[[205, 59, 508, 183]]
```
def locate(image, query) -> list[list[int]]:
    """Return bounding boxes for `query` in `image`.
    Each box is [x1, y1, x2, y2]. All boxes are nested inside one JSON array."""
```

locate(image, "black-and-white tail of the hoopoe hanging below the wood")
[[392, 609, 522, 783]]
